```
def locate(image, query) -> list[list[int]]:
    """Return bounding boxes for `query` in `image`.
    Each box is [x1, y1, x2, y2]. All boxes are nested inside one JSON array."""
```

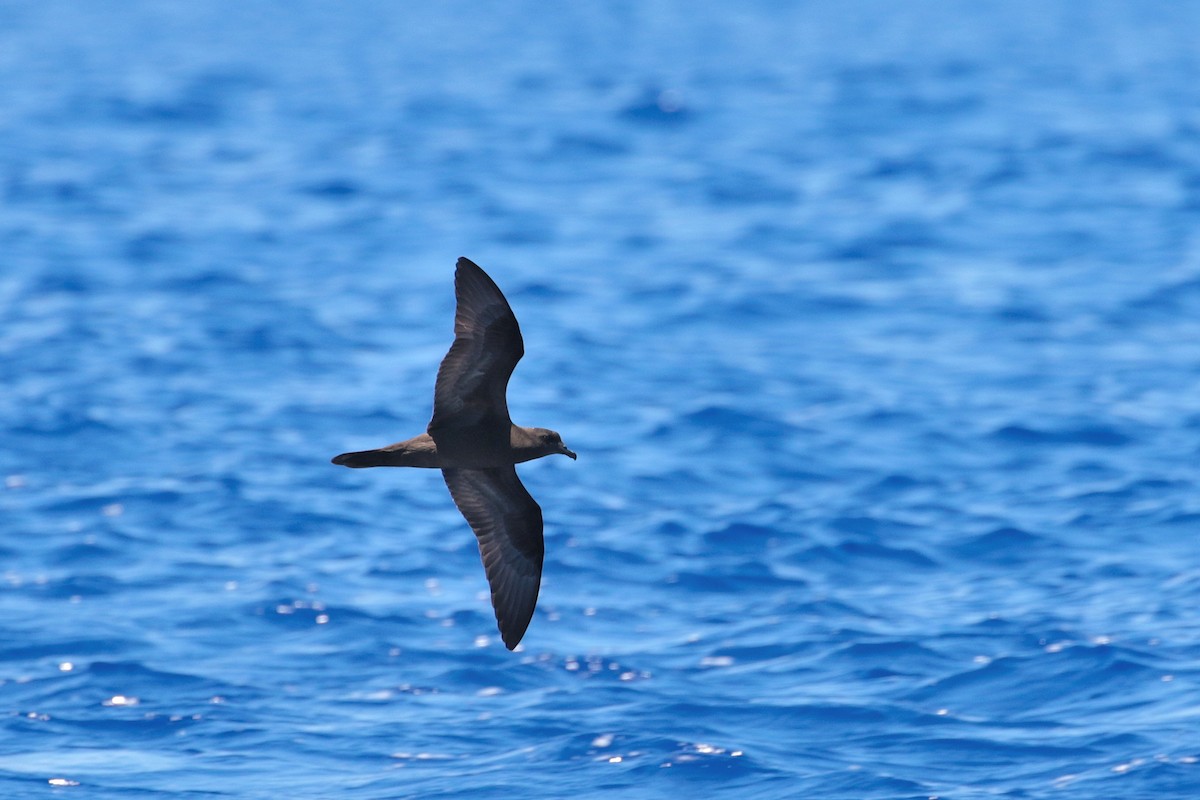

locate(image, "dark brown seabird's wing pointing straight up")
[[430, 258, 524, 449]]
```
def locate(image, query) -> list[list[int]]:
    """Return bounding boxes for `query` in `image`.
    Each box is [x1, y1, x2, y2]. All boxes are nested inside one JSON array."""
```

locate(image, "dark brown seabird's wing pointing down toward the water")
[[442, 467, 545, 650]]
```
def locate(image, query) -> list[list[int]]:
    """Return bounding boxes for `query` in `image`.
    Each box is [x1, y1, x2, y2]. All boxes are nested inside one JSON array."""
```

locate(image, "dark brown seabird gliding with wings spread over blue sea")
[[334, 258, 575, 650]]
